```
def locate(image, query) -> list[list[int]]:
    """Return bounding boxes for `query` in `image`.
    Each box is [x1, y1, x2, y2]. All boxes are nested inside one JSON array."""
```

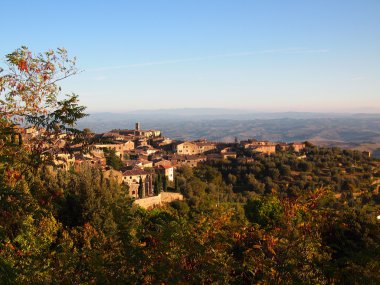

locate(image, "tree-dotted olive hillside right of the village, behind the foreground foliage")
[[199, 144, 380, 198]]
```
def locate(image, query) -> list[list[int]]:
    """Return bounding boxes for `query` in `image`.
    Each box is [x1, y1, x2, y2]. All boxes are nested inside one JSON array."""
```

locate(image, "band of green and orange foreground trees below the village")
[[0, 154, 380, 284]]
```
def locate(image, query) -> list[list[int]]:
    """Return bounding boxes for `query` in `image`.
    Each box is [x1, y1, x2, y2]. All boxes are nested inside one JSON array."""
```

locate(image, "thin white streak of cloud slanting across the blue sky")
[[88, 48, 329, 71]]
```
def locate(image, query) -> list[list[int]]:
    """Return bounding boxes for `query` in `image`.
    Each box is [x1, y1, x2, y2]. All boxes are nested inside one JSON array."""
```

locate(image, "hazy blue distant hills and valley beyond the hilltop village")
[[78, 109, 380, 156]]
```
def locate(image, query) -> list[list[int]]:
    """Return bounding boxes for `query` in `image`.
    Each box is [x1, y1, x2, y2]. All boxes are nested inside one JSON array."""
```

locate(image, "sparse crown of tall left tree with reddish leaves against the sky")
[[0, 46, 86, 175]]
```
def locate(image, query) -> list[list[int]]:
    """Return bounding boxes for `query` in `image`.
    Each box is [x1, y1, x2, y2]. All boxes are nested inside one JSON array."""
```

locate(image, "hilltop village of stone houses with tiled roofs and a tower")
[[11, 123, 305, 199]]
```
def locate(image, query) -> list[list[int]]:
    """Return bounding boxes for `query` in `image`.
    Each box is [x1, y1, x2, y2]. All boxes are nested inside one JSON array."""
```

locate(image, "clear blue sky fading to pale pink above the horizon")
[[0, 0, 380, 112]]
